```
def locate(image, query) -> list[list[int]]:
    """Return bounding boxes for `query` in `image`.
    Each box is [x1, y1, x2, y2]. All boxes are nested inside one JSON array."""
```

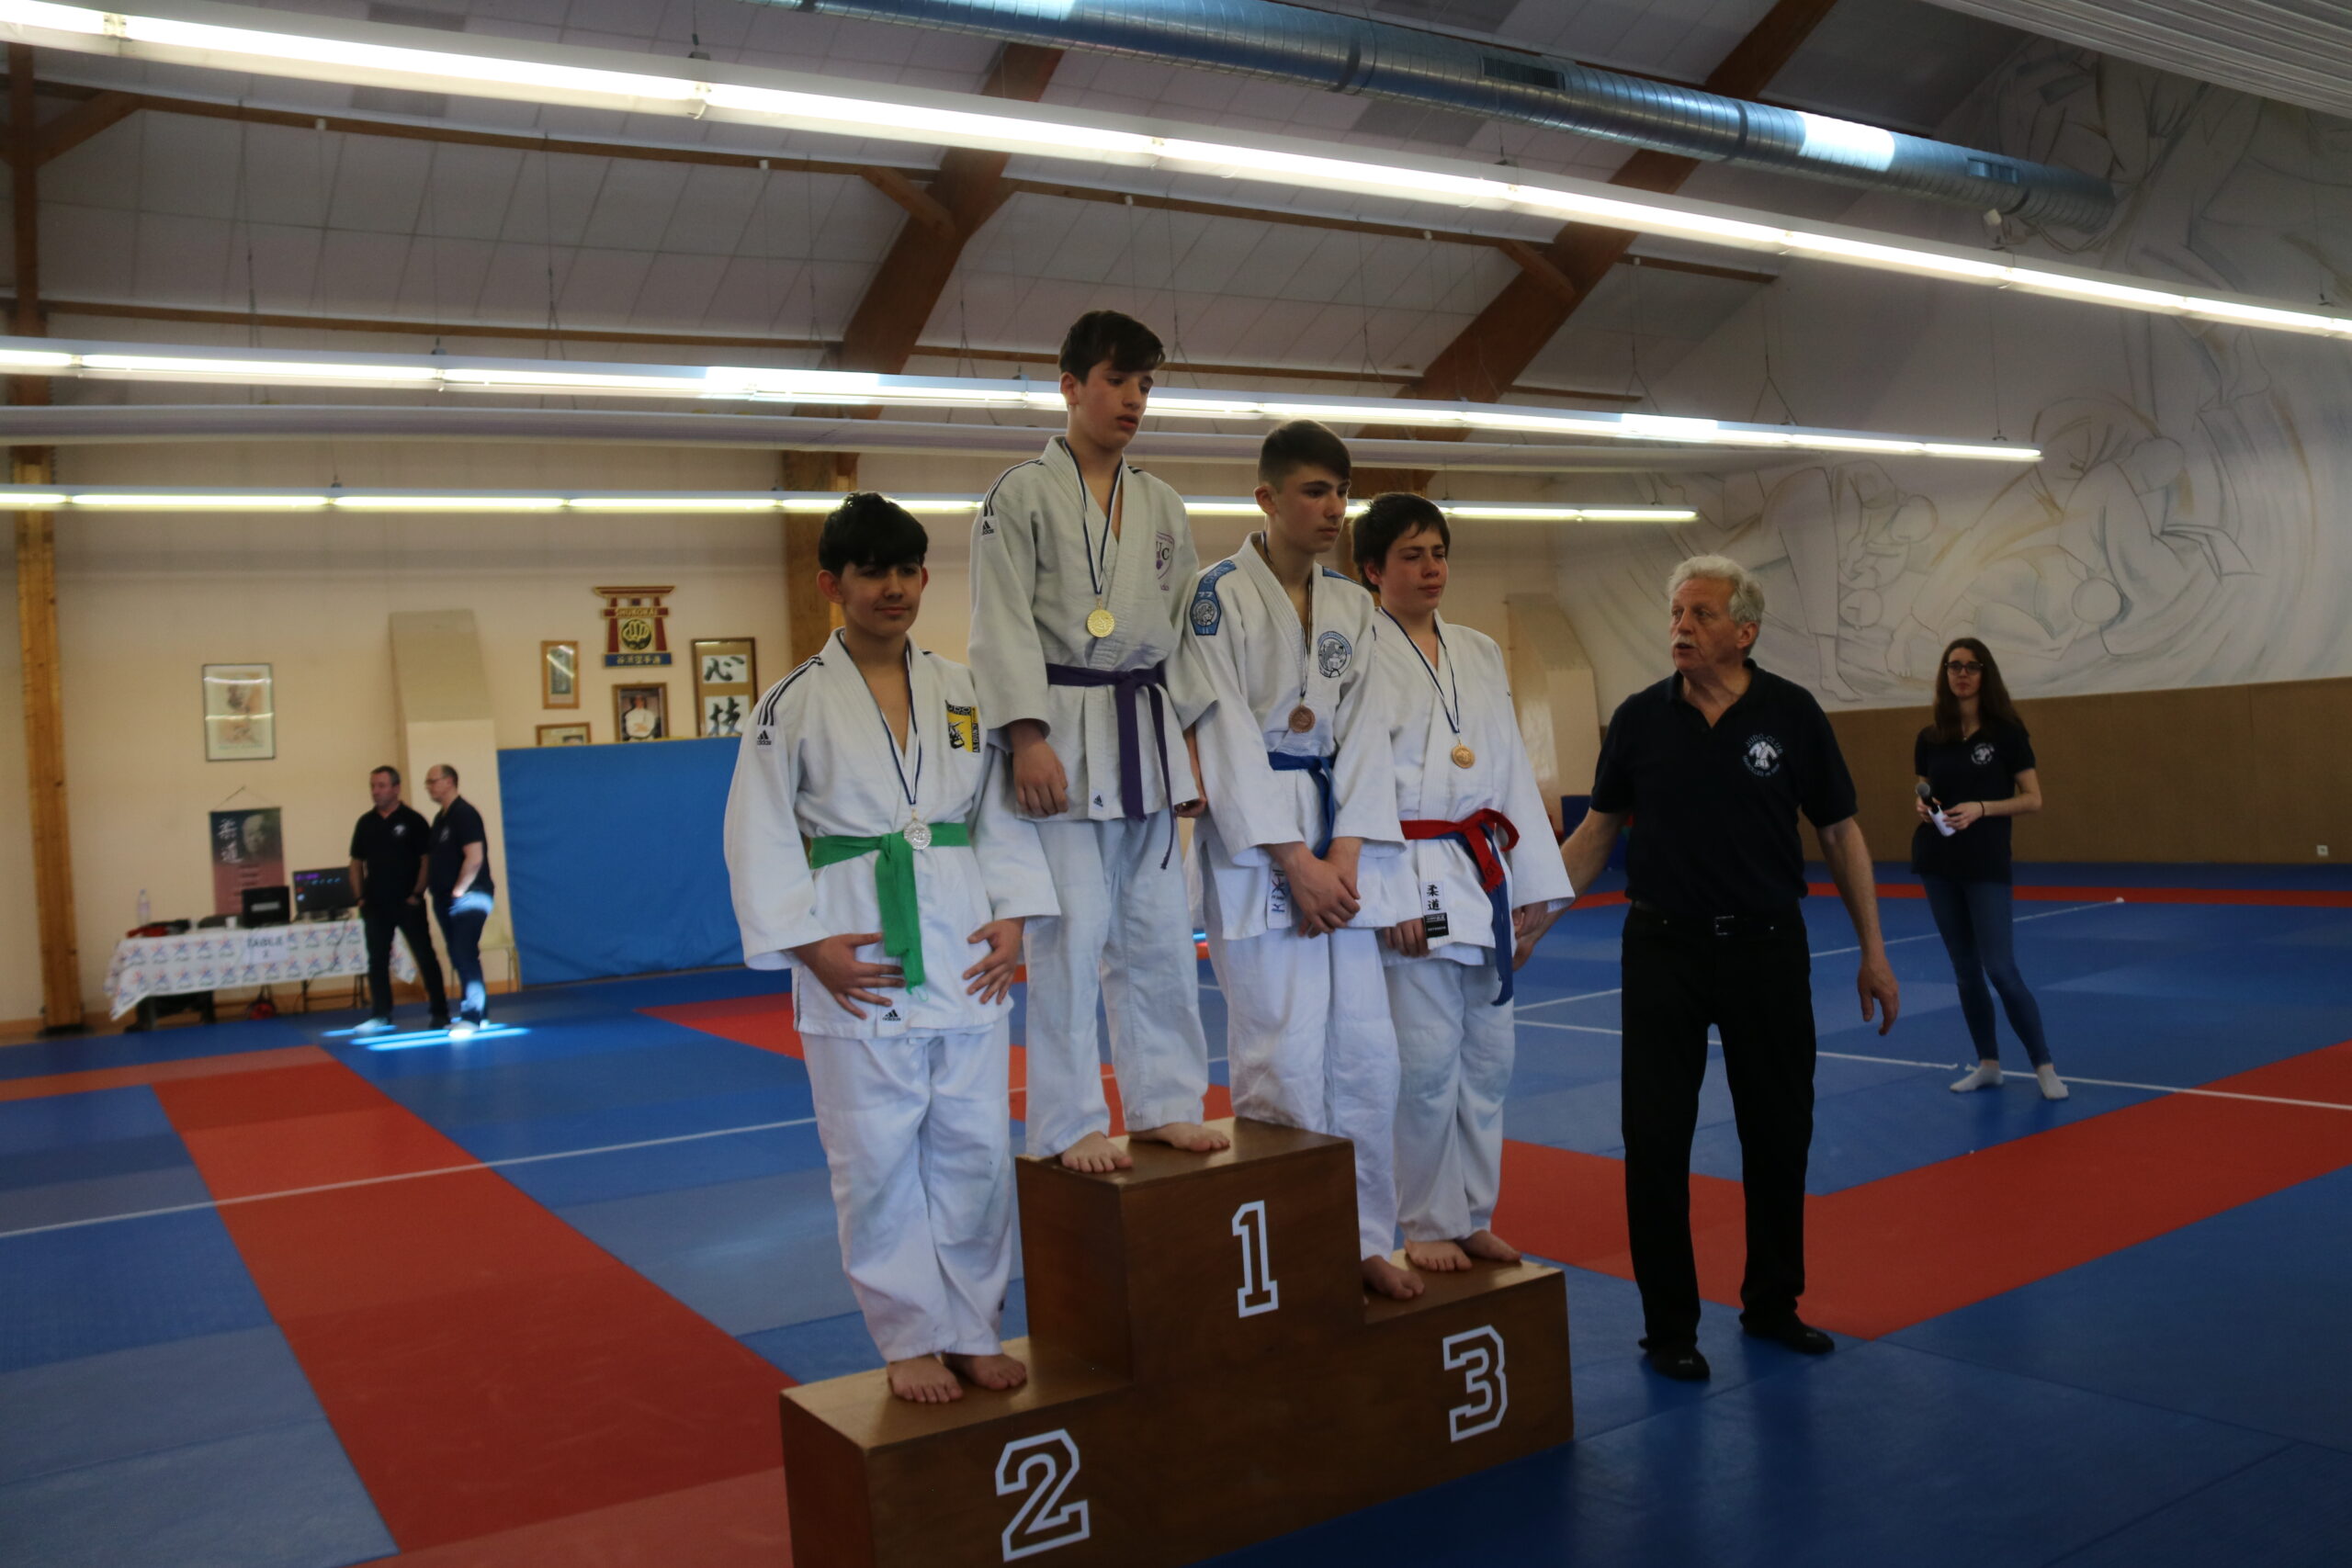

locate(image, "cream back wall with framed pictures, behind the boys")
[[0, 442, 1557, 1018]]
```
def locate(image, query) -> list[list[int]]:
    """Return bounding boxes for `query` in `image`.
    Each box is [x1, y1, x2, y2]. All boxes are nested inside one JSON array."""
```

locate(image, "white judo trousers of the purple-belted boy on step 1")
[[1021, 811, 1209, 1159]]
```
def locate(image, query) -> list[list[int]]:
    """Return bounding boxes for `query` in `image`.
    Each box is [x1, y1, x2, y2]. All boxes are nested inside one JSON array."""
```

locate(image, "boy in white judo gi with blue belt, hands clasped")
[[1185, 421, 1420, 1300]]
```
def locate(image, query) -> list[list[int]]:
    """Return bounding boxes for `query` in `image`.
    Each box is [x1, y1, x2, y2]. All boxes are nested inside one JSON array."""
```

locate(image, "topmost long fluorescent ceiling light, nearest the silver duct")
[[18, 0, 2352, 339]]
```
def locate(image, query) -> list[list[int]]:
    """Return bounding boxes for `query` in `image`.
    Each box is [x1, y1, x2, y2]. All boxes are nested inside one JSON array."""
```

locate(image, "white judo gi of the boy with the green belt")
[[727, 635, 1056, 1361]]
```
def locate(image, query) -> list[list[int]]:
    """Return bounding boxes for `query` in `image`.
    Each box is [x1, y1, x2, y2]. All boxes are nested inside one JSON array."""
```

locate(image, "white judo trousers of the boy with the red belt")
[[1381, 957, 1512, 1241]]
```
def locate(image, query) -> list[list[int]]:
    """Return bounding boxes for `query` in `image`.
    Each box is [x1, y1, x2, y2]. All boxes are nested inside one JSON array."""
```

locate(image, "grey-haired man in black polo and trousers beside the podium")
[[1562, 555, 1898, 1380]]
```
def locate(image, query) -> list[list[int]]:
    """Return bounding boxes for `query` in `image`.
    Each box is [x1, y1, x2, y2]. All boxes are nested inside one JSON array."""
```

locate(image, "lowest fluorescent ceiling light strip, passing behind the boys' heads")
[[0, 484, 1698, 522]]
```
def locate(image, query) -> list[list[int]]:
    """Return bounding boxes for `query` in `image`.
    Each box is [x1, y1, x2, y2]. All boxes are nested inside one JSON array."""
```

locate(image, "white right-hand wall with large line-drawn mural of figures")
[[1559, 45, 2352, 707]]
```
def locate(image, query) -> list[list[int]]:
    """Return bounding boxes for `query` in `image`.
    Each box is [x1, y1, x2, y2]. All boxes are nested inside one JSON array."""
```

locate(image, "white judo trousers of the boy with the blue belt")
[[1209, 907, 1397, 1258]]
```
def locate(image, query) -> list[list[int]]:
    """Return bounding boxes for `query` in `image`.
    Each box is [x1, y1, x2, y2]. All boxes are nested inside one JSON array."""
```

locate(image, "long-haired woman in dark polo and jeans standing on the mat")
[[1912, 637, 2067, 1100]]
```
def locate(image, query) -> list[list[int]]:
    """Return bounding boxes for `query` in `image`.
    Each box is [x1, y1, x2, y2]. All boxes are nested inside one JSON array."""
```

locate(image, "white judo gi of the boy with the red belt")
[[1371, 614, 1571, 1241]]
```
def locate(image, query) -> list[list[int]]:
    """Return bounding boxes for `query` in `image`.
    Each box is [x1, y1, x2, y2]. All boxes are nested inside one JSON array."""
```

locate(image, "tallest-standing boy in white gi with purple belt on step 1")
[[971, 310, 1227, 1170]]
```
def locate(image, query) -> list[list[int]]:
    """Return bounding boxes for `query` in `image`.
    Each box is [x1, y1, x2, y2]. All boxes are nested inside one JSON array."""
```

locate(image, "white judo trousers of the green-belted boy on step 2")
[[802, 1021, 1013, 1361]]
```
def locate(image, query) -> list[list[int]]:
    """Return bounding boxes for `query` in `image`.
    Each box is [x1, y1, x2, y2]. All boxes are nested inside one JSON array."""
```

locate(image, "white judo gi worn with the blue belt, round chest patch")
[[1185, 543, 1408, 1258]]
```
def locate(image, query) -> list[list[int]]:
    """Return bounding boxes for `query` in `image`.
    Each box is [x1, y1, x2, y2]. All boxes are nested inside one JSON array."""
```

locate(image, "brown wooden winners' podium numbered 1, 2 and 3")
[[783, 1122, 1574, 1568]]
